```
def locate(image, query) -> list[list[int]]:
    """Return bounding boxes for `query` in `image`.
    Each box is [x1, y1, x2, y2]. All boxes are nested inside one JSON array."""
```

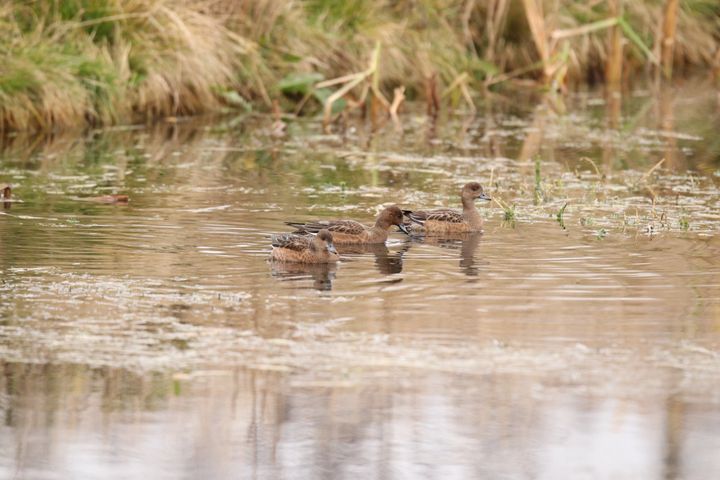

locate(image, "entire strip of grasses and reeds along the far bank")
[[0, 0, 720, 133]]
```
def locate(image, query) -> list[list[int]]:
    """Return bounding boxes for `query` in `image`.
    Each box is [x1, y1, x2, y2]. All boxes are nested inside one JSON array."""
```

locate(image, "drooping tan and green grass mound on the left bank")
[[0, 0, 262, 130]]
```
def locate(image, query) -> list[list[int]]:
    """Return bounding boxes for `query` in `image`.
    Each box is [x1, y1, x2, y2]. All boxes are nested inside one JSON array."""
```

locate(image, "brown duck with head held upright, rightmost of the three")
[[403, 182, 492, 233]]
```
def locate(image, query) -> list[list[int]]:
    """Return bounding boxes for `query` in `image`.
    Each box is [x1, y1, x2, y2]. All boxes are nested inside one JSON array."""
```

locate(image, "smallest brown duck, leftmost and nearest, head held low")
[[270, 229, 340, 263]]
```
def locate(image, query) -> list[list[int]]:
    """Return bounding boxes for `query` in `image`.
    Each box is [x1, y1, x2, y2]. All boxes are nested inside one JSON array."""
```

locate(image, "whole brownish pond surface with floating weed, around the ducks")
[[0, 83, 720, 479]]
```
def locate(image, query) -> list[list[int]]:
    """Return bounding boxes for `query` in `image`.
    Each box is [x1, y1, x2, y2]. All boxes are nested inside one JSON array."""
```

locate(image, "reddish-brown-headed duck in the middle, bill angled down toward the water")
[[285, 205, 410, 245]]
